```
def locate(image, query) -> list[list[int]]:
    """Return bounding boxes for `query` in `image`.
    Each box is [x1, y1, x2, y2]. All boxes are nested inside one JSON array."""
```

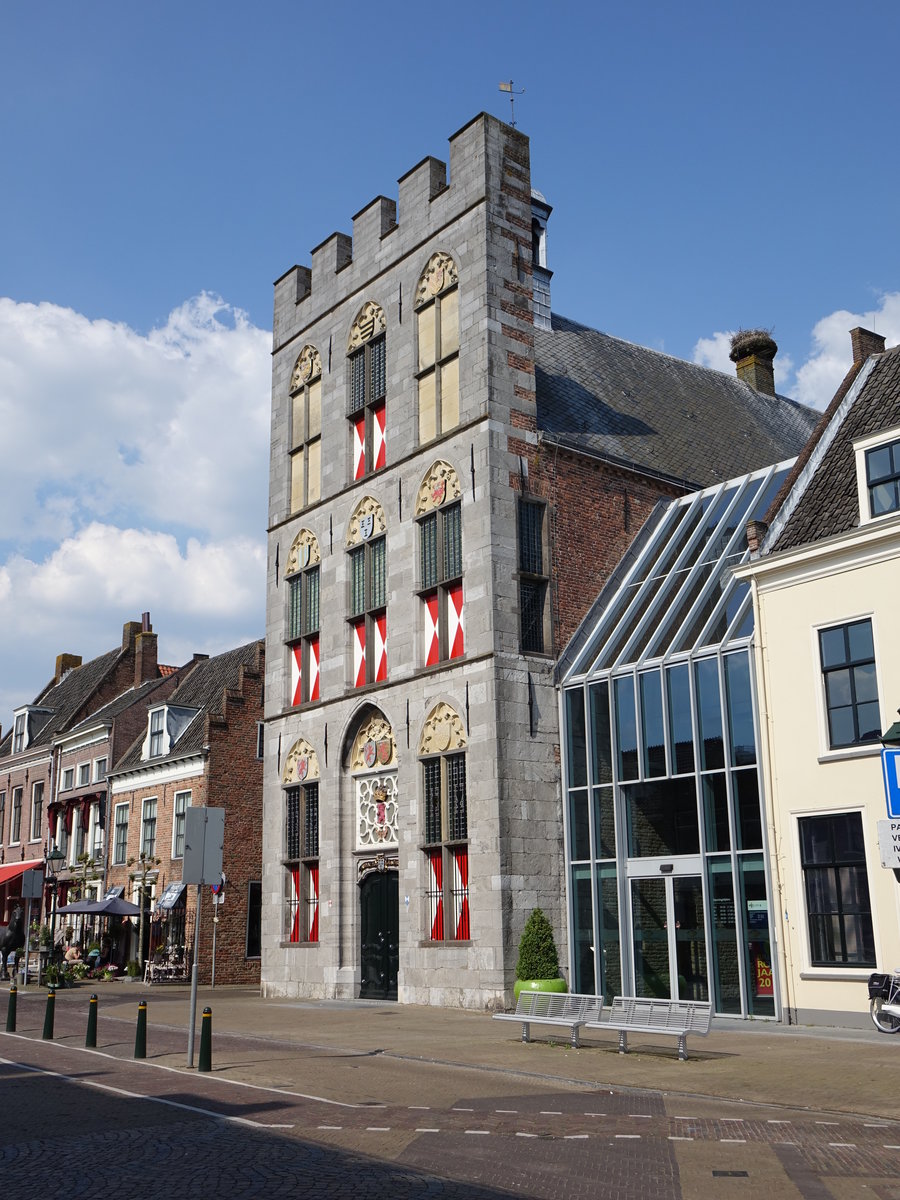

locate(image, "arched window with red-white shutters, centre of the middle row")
[[347, 496, 388, 688]]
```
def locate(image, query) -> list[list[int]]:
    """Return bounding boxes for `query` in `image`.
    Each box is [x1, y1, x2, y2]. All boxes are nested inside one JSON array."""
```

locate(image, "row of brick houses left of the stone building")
[[0, 614, 265, 983]]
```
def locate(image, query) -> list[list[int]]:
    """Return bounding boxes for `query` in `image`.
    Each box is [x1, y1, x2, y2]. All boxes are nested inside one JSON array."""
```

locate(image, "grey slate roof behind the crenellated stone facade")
[[534, 313, 821, 491]]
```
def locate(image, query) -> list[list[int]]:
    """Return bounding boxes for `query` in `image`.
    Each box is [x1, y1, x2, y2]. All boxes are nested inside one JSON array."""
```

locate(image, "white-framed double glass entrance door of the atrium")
[[631, 875, 709, 1000]]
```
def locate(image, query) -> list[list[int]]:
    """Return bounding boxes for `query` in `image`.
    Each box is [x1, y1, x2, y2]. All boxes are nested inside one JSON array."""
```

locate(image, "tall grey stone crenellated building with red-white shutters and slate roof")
[[262, 114, 812, 1007]]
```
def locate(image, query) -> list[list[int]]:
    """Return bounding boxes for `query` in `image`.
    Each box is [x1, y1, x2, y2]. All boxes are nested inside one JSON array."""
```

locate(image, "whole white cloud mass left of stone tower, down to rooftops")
[[0, 294, 271, 727]]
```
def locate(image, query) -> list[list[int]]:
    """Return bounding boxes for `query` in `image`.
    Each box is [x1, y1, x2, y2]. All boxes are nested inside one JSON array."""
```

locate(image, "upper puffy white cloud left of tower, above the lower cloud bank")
[[0, 294, 271, 542]]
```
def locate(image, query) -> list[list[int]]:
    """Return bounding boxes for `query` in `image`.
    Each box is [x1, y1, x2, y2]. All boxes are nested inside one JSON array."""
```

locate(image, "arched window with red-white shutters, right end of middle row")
[[415, 462, 466, 666]]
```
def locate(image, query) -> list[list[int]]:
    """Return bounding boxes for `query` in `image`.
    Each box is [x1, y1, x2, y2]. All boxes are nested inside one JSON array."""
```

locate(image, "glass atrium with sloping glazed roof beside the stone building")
[[559, 462, 792, 1016]]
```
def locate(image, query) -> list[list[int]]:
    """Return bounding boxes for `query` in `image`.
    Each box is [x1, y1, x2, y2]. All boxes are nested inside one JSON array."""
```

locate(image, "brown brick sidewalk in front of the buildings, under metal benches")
[[8, 982, 900, 1120]]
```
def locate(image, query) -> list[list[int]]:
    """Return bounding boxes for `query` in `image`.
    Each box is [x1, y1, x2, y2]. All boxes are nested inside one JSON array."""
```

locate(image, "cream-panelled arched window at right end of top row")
[[415, 253, 460, 444]]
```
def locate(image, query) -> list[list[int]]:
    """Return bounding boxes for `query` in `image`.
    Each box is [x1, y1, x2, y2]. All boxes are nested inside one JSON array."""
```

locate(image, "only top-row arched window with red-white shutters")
[[347, 300, 388, 479]]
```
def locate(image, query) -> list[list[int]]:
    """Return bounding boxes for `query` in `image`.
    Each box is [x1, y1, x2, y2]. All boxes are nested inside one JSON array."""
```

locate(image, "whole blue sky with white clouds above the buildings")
[[0, 0, 900, 727]]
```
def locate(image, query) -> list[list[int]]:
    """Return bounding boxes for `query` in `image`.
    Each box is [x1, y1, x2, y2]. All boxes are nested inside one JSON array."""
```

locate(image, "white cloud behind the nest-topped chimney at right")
[[692, 292, 900, 409]]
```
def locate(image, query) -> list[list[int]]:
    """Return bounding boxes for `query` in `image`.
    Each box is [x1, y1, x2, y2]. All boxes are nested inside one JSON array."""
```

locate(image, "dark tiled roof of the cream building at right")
[[764, 346, 900, 553]]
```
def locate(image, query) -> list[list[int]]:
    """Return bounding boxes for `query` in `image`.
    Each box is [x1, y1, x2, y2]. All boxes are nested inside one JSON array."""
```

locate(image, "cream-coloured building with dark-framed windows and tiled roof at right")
[[736, 330, 900, 1025]]
